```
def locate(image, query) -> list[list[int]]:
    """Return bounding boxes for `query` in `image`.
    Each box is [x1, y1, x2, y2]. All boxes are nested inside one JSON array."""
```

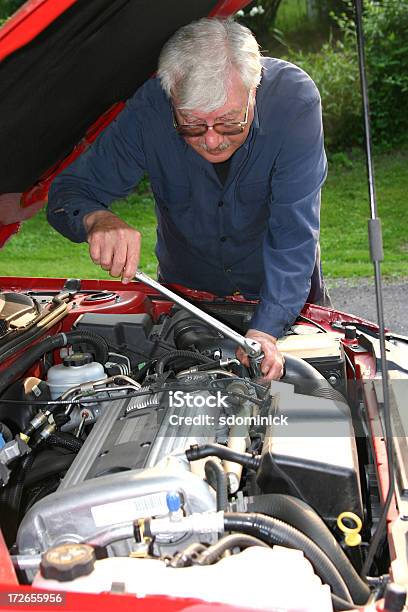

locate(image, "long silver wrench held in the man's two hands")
[[135, 272, 264, 376]]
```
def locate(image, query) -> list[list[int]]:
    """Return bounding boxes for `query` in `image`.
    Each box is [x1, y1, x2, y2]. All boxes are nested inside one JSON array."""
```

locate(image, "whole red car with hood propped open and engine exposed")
[[0, 0, 408, 612]]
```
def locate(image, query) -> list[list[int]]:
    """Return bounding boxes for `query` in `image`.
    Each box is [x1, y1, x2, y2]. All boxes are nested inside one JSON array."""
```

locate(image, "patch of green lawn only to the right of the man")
[[321, 151, 408, 277]]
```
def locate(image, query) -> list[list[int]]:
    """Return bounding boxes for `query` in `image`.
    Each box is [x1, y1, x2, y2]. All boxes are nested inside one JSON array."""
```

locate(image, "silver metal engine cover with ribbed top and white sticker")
[[17, 382, 226, 555]]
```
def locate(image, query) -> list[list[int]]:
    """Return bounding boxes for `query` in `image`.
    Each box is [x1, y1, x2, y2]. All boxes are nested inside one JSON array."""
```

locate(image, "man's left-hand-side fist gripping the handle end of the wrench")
[[84, 210, 142, 283]]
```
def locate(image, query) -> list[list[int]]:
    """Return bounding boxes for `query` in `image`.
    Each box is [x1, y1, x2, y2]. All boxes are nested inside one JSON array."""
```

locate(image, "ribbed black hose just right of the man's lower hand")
[[280, 353, 347, 403]]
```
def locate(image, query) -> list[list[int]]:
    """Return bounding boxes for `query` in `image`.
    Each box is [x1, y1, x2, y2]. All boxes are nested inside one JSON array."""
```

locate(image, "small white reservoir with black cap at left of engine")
[[47, 353, 107, 399]]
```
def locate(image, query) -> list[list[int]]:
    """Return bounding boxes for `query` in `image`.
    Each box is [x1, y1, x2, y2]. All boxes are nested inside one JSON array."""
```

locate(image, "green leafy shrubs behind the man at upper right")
[[286, 0, 408, 151]]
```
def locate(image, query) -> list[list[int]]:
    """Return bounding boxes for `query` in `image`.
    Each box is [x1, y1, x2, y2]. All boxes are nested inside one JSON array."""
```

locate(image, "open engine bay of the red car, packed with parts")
[[0, 279, 406, 612]]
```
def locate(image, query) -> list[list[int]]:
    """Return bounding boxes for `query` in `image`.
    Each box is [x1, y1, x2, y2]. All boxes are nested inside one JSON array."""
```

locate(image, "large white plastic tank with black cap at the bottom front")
[[33, 544, 333, 612]]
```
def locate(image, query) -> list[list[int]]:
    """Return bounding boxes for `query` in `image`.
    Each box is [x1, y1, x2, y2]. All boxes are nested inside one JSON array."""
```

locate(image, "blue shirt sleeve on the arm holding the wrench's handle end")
[[47, 98, 146, 242]]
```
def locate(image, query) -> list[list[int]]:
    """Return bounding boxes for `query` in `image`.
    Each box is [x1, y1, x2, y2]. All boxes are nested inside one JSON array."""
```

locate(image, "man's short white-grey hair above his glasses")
[[157, 19, 262, 113]]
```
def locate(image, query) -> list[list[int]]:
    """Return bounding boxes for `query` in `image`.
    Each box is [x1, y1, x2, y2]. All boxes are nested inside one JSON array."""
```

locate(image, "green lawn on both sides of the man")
[[0, 151, 408, 278]]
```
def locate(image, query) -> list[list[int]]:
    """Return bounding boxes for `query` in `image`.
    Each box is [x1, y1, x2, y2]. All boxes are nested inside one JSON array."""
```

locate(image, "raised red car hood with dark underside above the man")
[[0, 0, 250, 246]]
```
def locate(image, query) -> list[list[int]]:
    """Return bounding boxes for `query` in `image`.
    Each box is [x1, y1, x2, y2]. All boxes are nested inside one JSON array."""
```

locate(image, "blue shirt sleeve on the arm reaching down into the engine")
[[251, 97, 327, 337]]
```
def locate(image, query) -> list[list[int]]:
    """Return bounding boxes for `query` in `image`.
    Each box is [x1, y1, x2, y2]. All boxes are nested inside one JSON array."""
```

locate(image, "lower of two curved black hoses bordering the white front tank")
[[224, 512, 353, 603]]
